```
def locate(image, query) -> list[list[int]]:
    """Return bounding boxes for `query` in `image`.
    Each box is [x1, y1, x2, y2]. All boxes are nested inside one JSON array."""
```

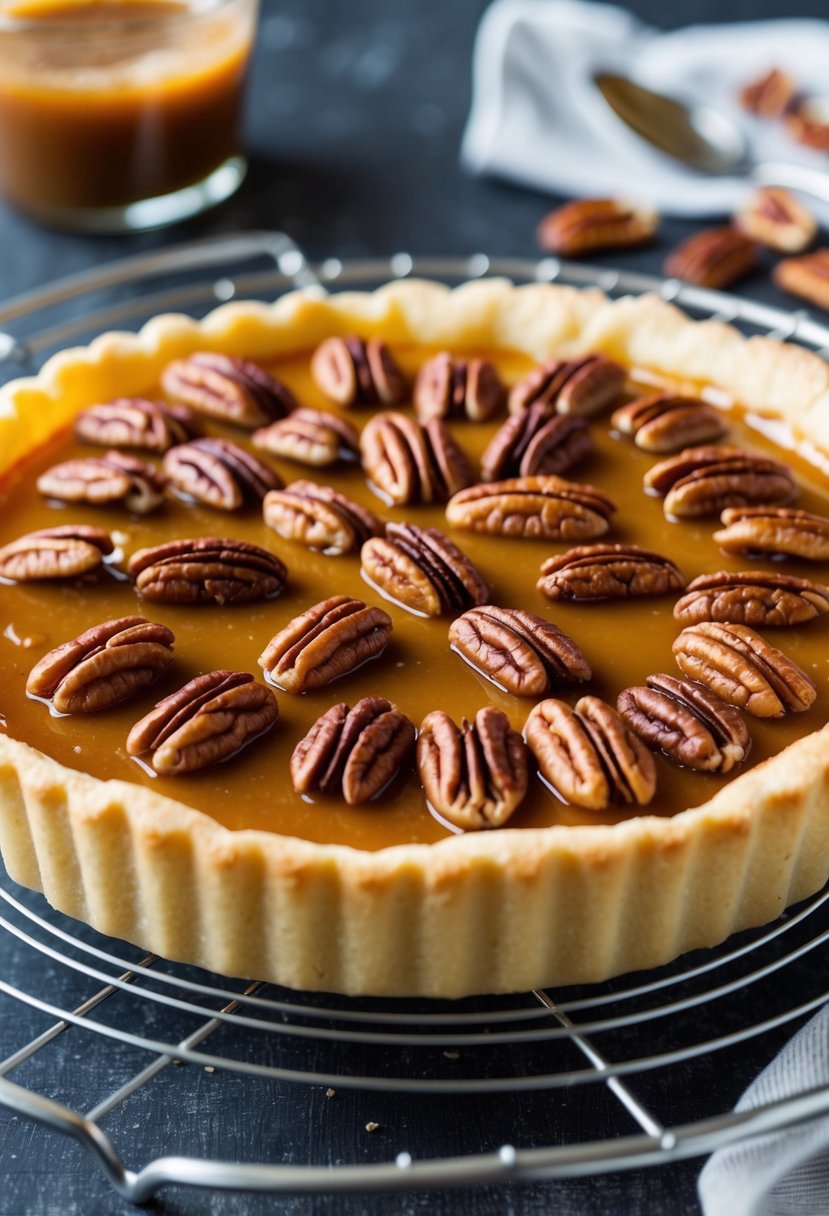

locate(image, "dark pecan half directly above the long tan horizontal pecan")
[[480, 401, 593, 482]]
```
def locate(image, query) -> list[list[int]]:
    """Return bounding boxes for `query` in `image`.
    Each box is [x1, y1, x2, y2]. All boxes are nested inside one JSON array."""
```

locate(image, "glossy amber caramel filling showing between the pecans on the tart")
[[0, 349, 829, 849]]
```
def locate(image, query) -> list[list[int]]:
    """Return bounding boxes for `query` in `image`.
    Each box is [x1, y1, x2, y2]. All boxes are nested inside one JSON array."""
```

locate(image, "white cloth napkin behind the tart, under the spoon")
[[461, 0, 829, 215]]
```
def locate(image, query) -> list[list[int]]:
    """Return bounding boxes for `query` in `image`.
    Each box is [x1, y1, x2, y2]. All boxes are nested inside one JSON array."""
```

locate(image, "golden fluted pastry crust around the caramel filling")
[[0, 280, 829, 997]]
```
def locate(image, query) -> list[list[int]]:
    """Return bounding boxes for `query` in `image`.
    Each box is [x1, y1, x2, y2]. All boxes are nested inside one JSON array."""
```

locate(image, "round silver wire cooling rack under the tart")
[[0, 232, 829, 1203]]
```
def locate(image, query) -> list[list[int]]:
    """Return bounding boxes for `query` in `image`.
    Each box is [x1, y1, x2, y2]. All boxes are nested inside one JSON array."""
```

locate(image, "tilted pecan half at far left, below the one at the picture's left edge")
[[26, 617, 175, 714]]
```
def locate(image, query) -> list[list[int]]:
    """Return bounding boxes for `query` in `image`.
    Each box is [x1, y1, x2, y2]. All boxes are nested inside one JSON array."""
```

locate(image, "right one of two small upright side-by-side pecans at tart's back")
[[412, 350, 507, 422]]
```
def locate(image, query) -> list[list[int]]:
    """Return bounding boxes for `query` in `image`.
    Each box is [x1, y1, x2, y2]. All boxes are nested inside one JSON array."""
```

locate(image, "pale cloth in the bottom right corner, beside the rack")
[[699, 1006, 829, 1216]]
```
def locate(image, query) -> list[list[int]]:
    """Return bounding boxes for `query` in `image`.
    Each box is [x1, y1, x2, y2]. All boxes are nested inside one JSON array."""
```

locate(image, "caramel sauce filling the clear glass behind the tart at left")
[[0, 0, 255, 227]]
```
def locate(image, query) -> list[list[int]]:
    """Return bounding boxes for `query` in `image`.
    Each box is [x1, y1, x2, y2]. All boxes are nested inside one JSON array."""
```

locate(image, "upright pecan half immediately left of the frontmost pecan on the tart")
[[291, 697, 416, 806]]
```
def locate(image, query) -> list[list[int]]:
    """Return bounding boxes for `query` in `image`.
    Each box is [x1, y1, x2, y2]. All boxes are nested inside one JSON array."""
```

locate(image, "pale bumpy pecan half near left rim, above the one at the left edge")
[[38, 451, 164, 516]]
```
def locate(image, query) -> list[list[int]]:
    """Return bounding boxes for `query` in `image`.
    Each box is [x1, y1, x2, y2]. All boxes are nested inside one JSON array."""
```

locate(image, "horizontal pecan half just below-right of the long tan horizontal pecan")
[[536, 545, 686, 602]]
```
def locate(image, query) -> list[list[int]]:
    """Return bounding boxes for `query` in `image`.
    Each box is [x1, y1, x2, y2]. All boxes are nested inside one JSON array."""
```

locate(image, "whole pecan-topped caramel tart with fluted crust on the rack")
[[0, 280, 829, 997]]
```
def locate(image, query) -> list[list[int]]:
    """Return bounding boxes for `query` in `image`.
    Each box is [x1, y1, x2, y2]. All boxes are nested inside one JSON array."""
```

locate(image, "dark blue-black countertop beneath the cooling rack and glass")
[[0, 0, 825, 1216]]
